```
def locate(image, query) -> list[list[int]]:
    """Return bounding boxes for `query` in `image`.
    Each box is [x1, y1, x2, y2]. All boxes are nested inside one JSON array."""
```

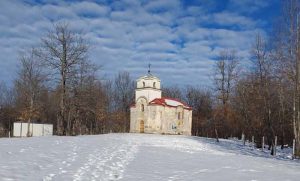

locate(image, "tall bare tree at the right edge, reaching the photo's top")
[[271, 0, 300, 156]]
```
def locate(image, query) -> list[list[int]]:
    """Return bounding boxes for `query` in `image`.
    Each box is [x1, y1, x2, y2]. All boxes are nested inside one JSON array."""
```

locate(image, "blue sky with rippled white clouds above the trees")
[[0, 0, 280, 86]]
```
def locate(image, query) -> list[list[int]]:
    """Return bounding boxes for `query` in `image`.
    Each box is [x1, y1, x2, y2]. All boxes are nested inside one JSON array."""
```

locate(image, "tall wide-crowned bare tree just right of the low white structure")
[[38, 23, 88, 135]]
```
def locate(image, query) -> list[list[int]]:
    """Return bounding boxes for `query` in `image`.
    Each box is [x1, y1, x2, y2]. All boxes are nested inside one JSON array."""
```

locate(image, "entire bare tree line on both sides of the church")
[[0, 0, 300, 156]]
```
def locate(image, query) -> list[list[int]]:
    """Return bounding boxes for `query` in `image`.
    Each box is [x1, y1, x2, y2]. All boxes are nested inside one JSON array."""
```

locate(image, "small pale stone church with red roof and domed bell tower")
[[130, 70, 192, 135]]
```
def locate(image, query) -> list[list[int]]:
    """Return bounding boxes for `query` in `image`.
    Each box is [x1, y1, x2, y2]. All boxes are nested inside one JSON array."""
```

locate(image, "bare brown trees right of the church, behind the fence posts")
[[165, 0, 300, 157]]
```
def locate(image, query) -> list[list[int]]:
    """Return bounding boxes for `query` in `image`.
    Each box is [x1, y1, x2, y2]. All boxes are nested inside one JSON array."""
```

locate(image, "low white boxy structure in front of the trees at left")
[[14, 122, 53, 137]]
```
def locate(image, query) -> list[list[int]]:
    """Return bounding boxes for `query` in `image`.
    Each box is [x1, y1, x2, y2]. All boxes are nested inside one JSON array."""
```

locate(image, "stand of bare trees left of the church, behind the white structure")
[[0, 23, 134, 136]]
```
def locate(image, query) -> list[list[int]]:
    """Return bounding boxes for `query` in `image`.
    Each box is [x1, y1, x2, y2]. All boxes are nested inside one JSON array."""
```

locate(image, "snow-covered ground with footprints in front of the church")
[[0, 134, 300, 181]]
